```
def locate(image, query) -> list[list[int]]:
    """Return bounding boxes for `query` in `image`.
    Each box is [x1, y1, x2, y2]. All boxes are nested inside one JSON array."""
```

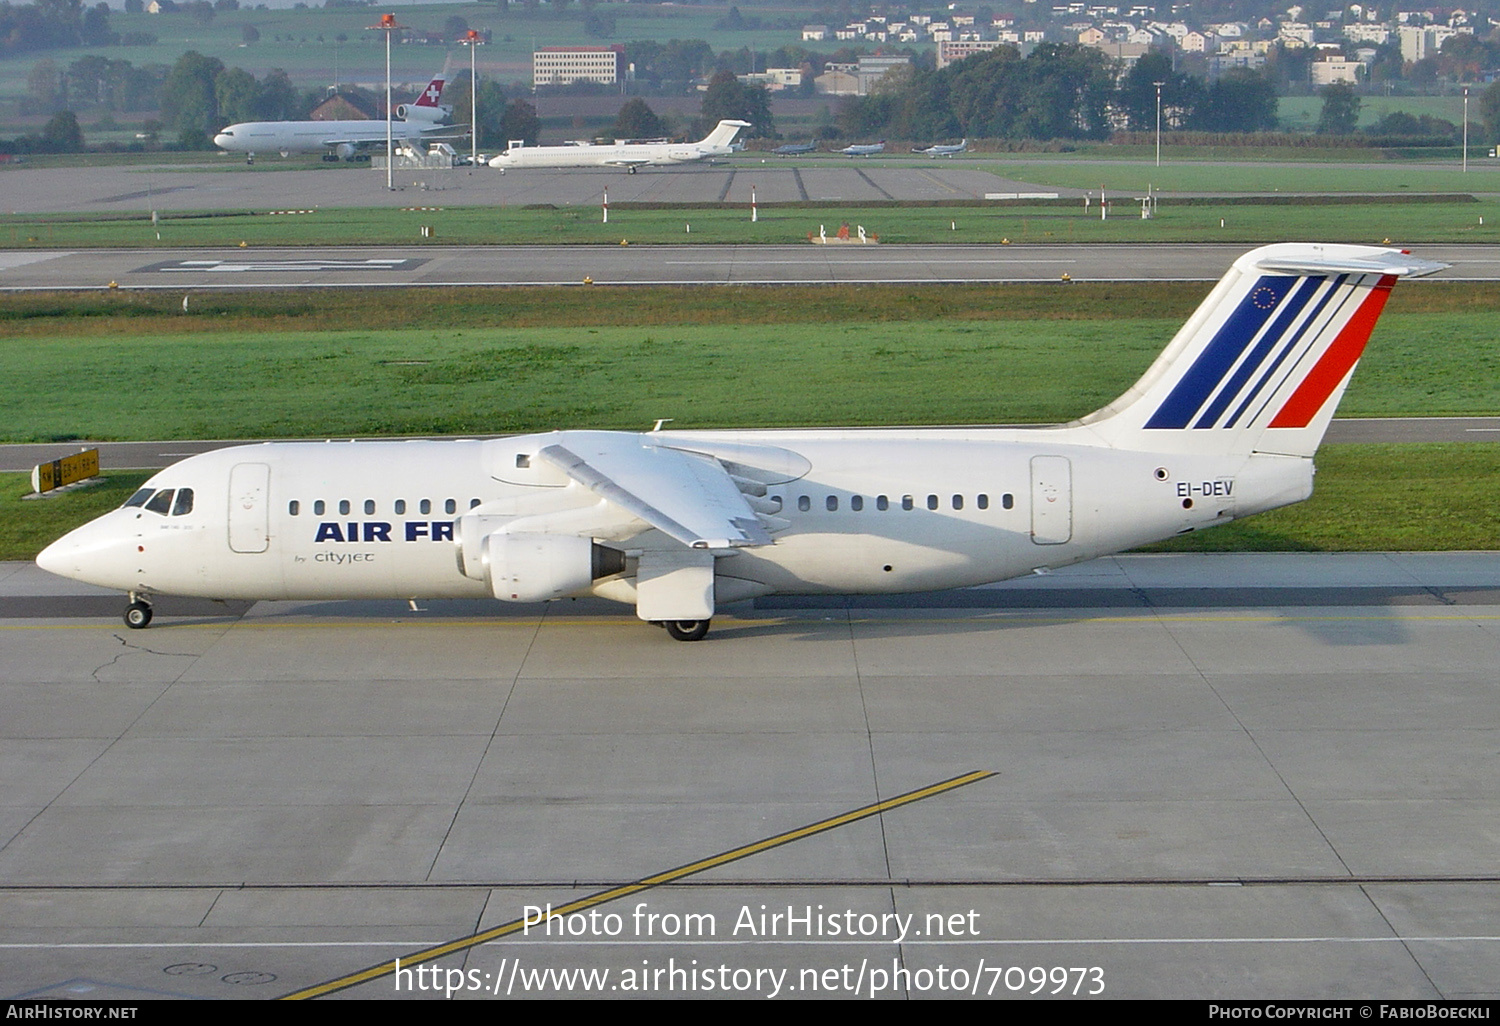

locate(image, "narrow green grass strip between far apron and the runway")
[[0, 191, 1500, 249]]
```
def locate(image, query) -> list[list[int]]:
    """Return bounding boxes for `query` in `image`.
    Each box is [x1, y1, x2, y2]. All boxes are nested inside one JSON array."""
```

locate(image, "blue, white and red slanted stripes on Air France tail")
[[1145, 275, 1395, 431]]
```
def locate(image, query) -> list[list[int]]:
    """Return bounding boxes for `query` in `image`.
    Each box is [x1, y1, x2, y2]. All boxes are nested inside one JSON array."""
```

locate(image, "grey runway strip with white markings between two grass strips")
[[0, 240, 1500, 293]]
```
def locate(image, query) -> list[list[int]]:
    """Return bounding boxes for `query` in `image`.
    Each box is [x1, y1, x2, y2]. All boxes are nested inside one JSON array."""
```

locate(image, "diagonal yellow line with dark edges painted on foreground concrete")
[[279, 770, 996, 1001]]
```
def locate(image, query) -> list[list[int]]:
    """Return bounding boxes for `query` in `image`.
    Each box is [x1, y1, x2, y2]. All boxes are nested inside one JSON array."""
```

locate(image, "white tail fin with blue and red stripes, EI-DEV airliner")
[[1077, 243, 1448, 456]]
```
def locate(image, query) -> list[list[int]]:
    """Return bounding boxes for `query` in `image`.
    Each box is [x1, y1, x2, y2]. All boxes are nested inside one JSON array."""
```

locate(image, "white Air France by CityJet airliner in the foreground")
[[36, 245, 1445, 641]]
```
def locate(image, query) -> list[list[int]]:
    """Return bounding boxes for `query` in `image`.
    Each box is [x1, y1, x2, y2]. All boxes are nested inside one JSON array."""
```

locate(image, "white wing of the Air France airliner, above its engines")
[[537, 432, 771, 549]]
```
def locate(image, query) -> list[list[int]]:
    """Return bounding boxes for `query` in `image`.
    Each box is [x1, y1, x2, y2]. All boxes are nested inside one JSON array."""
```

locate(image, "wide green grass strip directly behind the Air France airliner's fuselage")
[[0, 284, 1500, 441]]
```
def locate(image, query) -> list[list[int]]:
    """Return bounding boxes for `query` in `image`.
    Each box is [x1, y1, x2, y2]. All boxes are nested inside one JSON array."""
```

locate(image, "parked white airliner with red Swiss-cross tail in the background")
[[213, 75, 450, 162]]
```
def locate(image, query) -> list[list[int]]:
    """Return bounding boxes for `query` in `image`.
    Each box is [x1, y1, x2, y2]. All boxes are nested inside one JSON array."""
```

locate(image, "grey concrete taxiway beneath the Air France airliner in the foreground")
[[0, 554, 1500, 1001]]
